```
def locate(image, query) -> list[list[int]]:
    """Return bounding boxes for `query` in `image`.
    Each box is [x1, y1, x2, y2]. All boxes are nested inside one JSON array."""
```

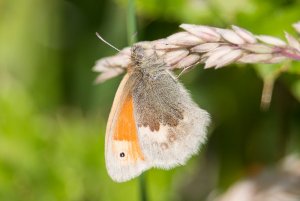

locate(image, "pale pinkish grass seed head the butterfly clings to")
[[93, 22, 300, 82]]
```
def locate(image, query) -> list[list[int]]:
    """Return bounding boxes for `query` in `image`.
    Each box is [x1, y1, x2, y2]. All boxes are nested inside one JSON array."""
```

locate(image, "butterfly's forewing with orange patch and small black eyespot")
[[105, 75, 149, 182]]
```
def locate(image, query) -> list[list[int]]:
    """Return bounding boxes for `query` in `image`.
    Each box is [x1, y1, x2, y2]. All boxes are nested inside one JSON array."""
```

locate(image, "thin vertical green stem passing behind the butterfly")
[[127, 0, 147, 201]]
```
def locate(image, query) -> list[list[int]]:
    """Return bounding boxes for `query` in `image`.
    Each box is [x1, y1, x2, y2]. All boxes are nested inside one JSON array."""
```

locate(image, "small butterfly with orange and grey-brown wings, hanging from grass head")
[[105, 44, 210, 182]]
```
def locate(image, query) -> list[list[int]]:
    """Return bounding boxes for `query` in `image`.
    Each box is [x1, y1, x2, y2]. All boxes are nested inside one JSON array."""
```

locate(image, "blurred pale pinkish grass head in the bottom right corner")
[[213, 155, 300, 201]]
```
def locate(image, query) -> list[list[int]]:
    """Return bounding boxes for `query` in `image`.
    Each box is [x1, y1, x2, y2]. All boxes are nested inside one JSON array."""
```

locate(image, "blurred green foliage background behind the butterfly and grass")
[[0, 0, 300, 201]]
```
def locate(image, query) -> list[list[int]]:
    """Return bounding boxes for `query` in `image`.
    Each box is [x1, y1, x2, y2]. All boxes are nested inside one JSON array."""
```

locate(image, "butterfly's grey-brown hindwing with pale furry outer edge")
[[133, 71, 210, 169]]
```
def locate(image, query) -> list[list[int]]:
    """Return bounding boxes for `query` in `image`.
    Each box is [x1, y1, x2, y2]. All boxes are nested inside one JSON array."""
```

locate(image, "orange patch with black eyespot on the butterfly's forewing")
[[113, 96, 144, 161]]
